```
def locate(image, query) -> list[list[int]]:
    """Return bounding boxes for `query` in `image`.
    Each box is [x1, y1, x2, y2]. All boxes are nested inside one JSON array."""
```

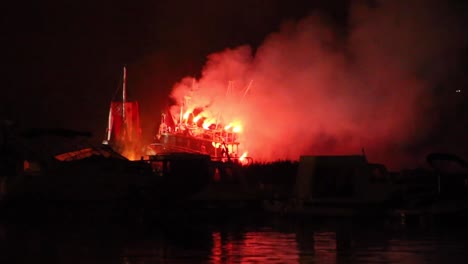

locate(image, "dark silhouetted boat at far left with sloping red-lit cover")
[[0, 128, 150, 221]]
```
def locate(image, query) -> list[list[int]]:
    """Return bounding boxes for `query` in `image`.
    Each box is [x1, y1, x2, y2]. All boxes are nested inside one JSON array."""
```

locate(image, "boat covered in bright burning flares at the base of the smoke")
[[146, 80, 253, 165]]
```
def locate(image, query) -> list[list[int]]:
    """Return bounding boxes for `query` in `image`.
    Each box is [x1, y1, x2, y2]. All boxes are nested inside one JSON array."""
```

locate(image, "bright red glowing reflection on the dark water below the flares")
[[210, 230, 351, 264]]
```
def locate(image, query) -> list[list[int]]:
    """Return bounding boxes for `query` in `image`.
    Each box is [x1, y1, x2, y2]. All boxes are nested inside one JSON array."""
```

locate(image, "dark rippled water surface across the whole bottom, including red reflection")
[[0, 216, 468, 264]]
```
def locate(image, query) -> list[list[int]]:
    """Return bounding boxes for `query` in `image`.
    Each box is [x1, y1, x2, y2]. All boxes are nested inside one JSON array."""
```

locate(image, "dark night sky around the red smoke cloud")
[[0, 0, 468, 167]]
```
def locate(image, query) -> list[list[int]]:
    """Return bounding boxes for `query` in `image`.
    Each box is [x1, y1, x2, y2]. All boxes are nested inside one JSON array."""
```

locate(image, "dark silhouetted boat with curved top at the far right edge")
[[390, 153, 468, 225]]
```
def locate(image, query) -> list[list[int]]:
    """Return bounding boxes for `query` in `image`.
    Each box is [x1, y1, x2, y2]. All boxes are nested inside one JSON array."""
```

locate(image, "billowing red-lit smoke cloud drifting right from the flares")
[[166, 1, 466, 167]]
